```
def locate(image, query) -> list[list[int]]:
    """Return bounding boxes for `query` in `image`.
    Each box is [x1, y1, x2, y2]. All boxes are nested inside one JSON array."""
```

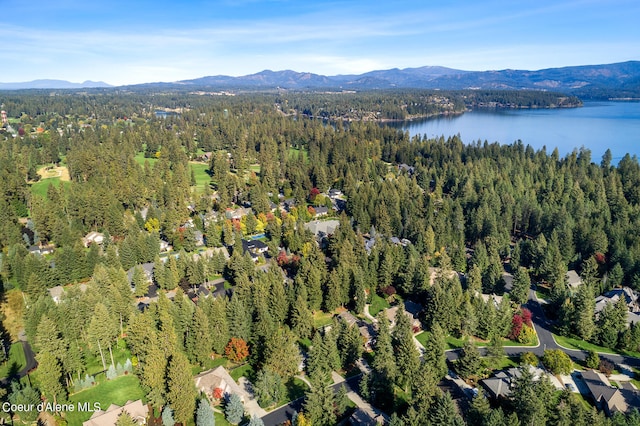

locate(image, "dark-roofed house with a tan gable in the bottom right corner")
[[582, 370, 640, 416]]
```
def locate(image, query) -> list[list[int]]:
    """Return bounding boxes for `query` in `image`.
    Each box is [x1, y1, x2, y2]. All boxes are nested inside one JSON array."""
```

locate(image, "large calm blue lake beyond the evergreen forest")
[[389, 101, 640, 163]]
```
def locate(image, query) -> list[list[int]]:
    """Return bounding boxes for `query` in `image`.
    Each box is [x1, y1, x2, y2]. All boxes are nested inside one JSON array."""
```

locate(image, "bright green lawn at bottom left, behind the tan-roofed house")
[[66, 375, 145, 425]]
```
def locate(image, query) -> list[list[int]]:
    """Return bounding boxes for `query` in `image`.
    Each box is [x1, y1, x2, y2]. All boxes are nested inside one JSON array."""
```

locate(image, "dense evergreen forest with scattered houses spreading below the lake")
[[0, 92, 640, 425]]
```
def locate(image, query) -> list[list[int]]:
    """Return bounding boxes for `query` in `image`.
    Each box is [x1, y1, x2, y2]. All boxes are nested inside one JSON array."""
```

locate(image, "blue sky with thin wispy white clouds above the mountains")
[[0, 0, 640, 85]]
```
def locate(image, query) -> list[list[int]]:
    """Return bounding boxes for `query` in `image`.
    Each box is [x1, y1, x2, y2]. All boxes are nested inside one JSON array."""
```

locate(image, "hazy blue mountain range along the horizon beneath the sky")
[[0, 61, 640, 97]]
